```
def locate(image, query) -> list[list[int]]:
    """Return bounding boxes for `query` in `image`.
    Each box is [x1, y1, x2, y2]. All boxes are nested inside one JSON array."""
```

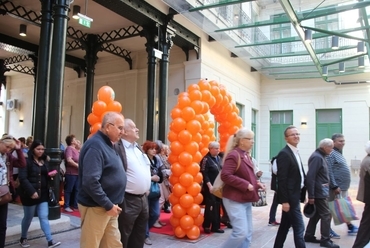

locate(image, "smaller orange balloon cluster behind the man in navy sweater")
[[87, 86, 122, 137]]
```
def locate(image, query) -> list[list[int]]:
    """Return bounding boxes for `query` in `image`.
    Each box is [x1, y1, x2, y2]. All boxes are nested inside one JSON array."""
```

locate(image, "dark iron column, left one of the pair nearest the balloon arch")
[[140, 27, 157, 140]]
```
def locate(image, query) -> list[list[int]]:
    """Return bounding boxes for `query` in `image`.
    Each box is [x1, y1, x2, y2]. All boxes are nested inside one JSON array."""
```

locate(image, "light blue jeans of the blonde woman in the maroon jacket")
[[222, 198, 253, 248]]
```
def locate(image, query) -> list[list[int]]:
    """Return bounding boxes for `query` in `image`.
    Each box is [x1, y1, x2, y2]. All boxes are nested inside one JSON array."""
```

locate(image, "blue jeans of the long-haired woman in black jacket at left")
[[21, 202, 53, 241]]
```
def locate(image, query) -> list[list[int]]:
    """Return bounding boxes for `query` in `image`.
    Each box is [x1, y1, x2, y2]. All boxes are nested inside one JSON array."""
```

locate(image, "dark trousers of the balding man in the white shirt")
[[118, 193, 149, 248]]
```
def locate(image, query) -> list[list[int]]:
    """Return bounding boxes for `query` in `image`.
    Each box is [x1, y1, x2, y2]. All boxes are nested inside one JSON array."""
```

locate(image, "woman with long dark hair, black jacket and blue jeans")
[[18, 140, 61, 247]]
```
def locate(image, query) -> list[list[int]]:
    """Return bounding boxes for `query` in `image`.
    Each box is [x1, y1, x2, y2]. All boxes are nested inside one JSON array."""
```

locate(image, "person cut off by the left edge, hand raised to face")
[[0, 135, 26, 247]]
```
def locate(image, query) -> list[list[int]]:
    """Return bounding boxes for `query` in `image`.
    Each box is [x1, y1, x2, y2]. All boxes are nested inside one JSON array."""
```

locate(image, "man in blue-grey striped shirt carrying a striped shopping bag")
[[326, 133, 358, 239]]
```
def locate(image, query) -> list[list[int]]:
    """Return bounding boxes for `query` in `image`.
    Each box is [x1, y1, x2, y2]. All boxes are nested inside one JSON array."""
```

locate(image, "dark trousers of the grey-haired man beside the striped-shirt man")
[[304, 199, 331, 242]]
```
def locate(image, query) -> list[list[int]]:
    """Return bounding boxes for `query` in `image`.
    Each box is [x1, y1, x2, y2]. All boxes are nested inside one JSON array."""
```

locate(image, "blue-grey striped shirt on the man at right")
[[326, 147, 351, 191]]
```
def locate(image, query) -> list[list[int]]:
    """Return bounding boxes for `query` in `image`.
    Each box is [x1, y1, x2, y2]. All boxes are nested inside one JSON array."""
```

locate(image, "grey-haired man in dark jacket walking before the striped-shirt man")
[[304, 139, 339, 248]]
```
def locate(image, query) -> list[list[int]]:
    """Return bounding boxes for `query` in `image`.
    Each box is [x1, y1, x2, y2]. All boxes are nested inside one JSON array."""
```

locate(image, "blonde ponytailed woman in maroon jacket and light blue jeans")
[[221, 128, 265, 248]]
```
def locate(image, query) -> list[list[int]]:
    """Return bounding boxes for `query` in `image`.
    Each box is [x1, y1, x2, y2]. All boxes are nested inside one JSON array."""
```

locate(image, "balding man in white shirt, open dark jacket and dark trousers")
[[114, 119, 151, 248]]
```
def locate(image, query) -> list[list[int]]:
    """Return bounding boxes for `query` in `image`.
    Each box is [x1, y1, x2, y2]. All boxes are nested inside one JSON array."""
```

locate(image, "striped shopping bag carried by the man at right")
[[328, 196, 358, 225]]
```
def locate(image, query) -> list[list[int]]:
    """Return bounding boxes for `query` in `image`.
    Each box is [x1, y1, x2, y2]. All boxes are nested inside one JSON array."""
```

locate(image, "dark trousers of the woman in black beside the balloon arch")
[[203, 193, 221, 231]]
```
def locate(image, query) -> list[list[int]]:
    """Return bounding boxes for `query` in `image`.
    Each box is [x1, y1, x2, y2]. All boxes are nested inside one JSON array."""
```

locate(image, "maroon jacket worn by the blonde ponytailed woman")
[[221, 148, 259, 203]]
